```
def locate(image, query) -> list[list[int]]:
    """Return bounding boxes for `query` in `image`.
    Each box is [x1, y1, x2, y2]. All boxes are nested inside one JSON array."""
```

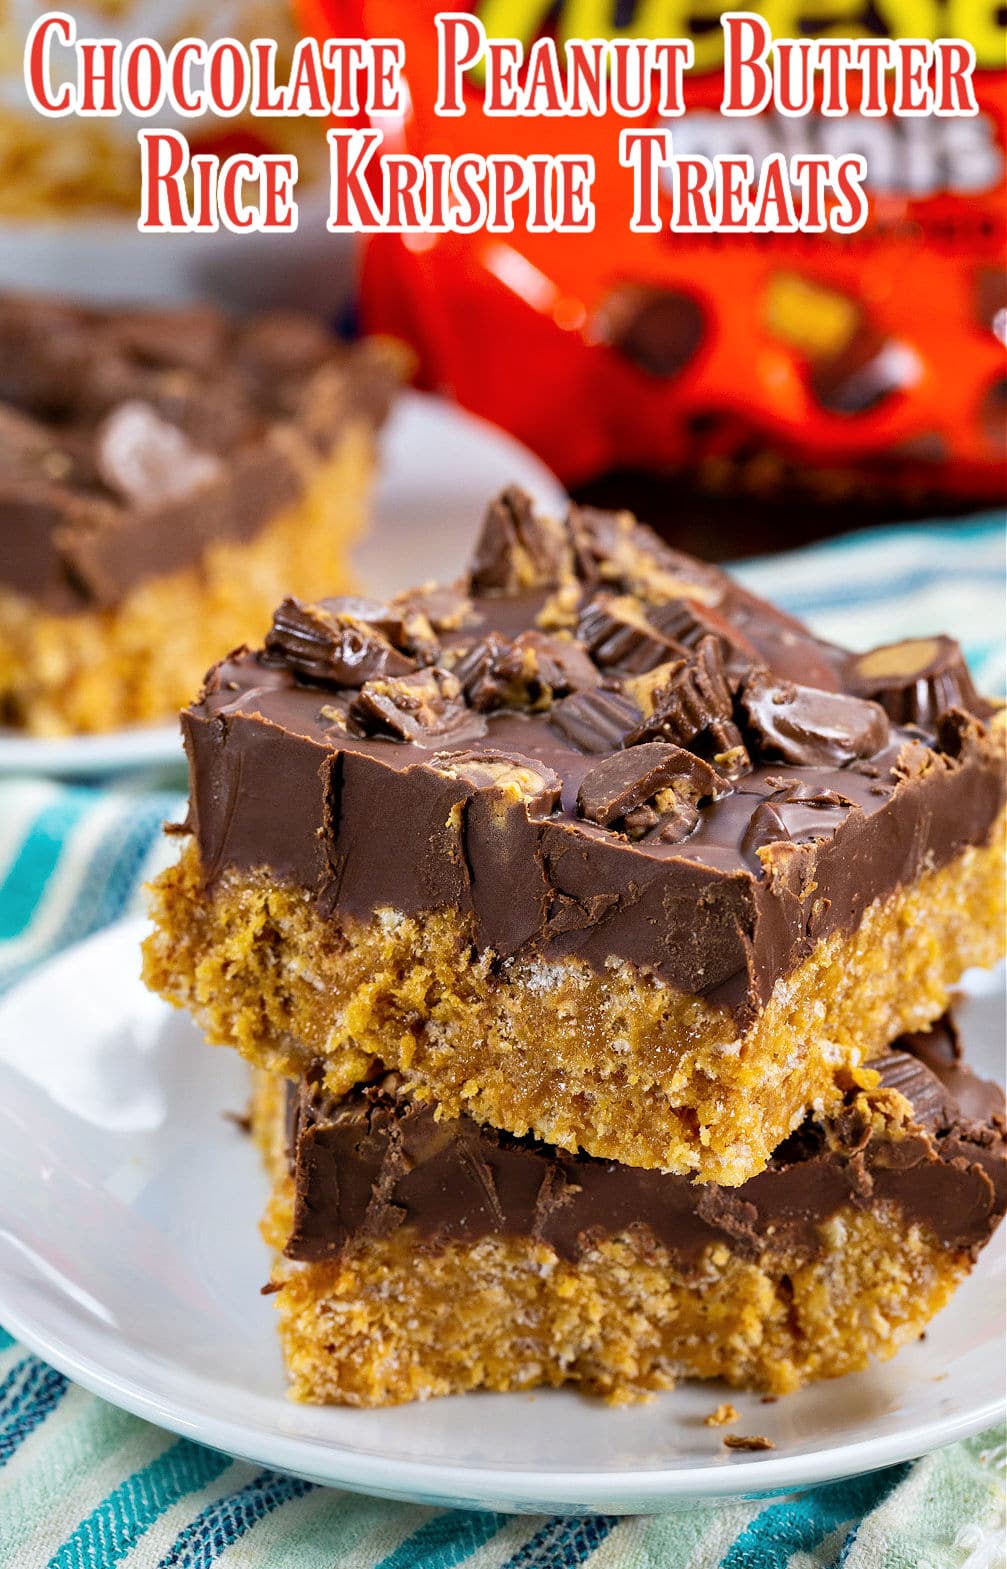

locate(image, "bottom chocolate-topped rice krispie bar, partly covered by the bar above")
[[253, 1023, 1007, 1406]]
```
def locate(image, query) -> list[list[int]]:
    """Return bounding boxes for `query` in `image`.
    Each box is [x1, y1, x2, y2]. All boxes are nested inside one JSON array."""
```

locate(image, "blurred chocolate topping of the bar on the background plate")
[[0, 295, 397, 613]]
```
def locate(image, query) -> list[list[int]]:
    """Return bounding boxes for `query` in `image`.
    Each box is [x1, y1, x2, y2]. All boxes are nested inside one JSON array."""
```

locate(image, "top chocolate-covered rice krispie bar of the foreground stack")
[[146, 493, 1004, 1185]]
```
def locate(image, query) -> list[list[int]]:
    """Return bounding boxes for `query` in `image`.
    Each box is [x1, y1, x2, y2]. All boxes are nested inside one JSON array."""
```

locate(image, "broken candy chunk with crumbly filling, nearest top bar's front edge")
[[577, 741, 734, 844]]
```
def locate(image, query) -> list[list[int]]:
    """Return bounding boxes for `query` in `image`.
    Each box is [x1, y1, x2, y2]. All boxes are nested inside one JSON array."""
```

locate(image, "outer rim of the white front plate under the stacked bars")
[[0, 915, 1007, 1514]]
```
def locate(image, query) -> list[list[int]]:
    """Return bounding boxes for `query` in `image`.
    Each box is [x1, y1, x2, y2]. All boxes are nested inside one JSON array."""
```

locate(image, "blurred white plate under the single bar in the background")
[[0, 392, 566, 778]]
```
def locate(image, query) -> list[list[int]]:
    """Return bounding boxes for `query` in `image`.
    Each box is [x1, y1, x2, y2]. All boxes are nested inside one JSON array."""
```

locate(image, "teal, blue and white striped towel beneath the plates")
[[0, 519, 1007, 1569]]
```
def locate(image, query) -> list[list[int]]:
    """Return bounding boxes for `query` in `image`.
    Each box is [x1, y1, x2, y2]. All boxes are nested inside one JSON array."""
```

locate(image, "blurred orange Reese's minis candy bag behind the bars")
[[301, 0, 1007, 507]]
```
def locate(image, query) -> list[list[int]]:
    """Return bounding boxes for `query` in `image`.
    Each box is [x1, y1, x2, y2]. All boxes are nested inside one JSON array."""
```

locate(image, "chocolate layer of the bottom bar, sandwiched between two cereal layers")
[[287, 1021, 1007, 1268]]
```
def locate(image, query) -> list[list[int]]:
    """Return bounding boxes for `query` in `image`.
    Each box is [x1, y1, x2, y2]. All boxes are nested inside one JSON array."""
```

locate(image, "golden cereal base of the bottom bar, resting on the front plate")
[[262, 1174, 969, 1406]]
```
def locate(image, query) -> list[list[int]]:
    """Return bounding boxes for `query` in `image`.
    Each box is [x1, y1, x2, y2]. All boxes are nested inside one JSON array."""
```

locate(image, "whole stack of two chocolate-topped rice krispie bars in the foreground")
[[146, 491, 1007, 1404]]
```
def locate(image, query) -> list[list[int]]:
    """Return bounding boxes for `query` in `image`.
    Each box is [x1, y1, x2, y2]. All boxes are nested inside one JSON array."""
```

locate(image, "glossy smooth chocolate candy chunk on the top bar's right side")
[[739, 672, 889, 767]]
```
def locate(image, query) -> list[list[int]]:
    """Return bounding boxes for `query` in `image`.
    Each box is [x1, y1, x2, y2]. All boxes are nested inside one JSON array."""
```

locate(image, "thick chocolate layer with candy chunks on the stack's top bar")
[[182, 491, 1004, 1028]]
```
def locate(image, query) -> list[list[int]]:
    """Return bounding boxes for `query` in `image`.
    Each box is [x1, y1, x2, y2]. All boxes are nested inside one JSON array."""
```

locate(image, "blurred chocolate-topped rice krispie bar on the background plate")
[[0, 297, 398, 736]]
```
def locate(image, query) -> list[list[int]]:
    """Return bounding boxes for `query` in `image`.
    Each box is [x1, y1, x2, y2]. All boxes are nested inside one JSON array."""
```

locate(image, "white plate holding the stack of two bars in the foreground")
[[0, 921, 1004, 1513]]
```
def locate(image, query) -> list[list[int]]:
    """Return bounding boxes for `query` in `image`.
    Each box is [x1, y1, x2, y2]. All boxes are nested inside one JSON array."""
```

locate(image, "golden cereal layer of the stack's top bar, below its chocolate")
[[144, 809, 1004, 1185]]
